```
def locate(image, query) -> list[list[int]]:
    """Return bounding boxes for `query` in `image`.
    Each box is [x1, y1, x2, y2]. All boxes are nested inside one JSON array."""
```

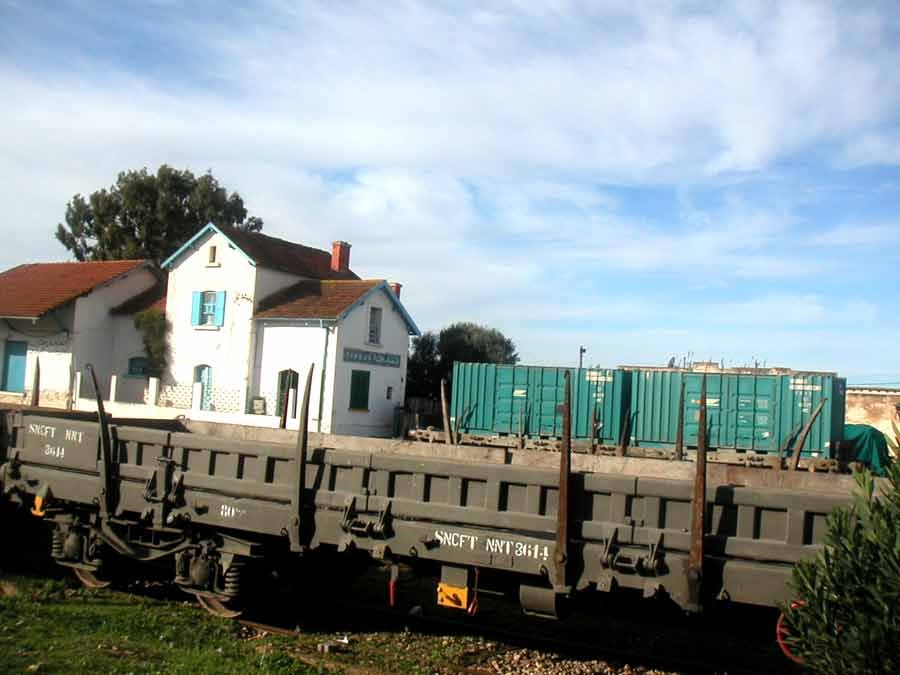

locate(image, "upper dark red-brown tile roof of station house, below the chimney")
[[219, 225, 359, 279]]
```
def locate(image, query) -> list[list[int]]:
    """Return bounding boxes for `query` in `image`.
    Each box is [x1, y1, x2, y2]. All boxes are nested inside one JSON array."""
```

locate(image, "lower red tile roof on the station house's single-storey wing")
[[253, 279, 384, 319]]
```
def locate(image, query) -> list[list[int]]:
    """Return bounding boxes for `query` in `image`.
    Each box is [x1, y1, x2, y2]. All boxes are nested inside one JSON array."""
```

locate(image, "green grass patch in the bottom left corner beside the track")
[[0, 576, 326, 675]]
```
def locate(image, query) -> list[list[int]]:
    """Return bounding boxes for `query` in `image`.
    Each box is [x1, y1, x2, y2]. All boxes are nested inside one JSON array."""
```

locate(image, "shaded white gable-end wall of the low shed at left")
[[72, 267, 156, 398]]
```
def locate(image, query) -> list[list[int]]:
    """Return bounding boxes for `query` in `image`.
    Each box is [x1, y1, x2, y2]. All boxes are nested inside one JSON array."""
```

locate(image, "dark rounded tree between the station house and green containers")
[[406, 322, 519, 398]]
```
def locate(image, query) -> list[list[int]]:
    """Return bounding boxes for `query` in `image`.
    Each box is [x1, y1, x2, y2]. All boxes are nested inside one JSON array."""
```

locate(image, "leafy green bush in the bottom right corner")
[[783, 462, 900, 675]]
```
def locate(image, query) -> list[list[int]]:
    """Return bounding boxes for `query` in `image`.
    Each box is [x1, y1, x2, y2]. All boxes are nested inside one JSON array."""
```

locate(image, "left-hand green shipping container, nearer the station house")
[[450, 362, 629, 445]]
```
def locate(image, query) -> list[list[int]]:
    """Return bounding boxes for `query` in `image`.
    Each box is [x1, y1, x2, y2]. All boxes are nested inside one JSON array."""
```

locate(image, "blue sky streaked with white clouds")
[[0, 0, 900, 384]]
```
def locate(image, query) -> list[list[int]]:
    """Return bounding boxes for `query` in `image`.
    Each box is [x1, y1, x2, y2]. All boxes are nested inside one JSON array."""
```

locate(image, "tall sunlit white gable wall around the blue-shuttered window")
[[164, 232, 256, 412]]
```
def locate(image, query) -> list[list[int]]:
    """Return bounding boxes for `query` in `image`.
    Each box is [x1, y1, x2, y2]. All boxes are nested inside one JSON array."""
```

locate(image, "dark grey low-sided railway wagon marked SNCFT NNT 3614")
[[0, 374, 872, 644]]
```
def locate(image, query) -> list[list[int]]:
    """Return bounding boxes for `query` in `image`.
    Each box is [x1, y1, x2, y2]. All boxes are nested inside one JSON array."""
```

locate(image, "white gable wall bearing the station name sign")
[[331, 291, 409, 436]]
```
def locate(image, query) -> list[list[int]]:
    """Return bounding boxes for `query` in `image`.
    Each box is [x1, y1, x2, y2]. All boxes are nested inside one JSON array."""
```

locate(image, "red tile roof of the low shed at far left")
[[0, 260, 147, 318]]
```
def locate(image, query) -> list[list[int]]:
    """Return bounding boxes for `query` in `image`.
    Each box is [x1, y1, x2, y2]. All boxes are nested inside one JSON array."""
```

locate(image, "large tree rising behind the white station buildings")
[[56, 164, 263, 263]]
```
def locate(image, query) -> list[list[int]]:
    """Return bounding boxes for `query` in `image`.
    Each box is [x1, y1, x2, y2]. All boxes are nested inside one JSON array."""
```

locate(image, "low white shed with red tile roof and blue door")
[[0, 260, 159, 405]]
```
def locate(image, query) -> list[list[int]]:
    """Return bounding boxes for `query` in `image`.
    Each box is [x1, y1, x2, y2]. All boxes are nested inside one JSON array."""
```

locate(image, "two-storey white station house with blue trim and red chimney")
[[159, 224, 418, 435]]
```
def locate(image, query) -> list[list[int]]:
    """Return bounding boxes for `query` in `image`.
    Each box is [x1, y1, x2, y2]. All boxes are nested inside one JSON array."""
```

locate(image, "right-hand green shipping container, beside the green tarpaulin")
[[628, 368, 846, 457]]
